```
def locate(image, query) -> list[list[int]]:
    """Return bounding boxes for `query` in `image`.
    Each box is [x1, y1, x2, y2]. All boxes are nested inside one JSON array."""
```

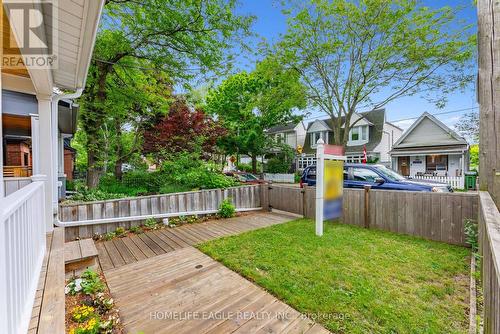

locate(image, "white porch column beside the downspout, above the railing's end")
[[37, 95, 55, 232]]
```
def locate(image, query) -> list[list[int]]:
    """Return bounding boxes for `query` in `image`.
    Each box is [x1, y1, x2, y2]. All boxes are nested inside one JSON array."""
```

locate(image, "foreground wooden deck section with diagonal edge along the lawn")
[[105, 247, 328, 334]]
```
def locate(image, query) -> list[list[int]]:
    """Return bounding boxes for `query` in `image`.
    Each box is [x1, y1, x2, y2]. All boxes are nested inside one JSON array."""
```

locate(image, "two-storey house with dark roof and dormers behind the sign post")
[[297, 109, 403, 170]]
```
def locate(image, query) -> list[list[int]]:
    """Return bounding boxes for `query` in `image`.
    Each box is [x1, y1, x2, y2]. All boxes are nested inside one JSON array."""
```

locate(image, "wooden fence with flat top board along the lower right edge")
[[479, 191, 500, 334]]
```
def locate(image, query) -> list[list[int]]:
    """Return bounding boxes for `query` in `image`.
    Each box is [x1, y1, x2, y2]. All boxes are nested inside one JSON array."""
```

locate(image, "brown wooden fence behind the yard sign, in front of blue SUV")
[[263, 185, 478, 245]]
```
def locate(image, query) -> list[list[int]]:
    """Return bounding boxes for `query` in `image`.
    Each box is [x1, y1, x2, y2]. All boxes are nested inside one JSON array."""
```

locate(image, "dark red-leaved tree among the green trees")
[[143, 99, 226, 161]]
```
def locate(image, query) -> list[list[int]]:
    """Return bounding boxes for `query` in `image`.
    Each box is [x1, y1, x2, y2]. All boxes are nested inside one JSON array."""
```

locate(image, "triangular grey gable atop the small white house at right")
[[393, 112, 468, 149]]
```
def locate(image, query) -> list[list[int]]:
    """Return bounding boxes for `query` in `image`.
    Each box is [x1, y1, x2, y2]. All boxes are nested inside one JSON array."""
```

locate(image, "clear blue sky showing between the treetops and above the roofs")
[[232, 0, 477, 134]]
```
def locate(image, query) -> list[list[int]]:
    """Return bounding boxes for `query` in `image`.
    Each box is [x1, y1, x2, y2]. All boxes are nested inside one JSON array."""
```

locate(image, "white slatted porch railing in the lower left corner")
[[0, 178, 46, 333]]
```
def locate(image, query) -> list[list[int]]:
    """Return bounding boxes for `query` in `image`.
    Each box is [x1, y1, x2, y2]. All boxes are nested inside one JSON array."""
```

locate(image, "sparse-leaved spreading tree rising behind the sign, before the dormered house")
[[271, 0, 475, 145]]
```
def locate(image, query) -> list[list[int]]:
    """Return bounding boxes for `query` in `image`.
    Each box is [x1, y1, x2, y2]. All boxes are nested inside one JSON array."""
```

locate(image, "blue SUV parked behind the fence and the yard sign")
[[300, 163, 453, 192]]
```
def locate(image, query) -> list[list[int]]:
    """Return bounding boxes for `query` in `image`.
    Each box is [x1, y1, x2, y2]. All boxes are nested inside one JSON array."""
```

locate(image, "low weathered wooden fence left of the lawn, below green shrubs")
[[59, 185, 263, 241]]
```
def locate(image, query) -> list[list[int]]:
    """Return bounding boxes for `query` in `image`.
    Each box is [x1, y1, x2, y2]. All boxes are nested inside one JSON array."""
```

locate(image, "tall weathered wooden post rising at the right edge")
[[477, 0, 500, 207]]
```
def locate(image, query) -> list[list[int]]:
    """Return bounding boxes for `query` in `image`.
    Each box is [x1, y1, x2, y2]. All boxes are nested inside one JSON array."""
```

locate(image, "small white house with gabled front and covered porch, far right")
[[390, 112, 469, 177]]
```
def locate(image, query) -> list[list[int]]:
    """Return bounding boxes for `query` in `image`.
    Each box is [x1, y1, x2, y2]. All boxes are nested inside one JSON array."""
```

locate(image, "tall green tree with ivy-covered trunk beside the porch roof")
[[81, 0, 252, 188]]
